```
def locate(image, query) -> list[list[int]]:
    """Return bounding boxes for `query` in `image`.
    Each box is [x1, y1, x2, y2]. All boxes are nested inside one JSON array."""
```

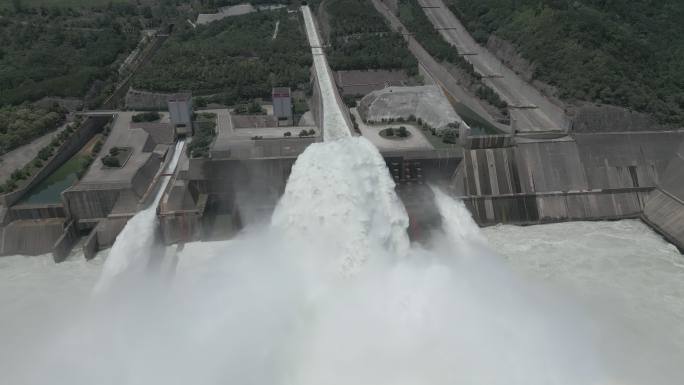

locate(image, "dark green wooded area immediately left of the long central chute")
[[133, 10, 312, 104]]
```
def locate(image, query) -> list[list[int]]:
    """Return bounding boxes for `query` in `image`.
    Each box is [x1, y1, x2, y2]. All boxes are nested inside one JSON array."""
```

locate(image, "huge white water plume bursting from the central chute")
[[272, 137, 409, 273]]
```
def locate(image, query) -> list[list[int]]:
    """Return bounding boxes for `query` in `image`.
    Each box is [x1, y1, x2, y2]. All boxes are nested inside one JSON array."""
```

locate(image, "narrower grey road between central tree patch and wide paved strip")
[[371, 0, 510, 132]]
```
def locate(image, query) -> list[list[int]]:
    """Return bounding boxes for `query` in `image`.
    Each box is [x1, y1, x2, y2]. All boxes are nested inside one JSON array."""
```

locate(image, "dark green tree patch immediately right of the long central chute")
[[323, 0, 418, 75]]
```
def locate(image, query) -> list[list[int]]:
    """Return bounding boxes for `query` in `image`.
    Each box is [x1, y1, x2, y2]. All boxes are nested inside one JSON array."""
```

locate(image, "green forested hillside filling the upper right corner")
[[449, 0, 684, 125]]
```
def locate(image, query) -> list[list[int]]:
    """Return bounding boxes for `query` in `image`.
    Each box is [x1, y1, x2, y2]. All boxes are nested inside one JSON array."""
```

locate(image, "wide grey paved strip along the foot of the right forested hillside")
[[418, 0, 569, 131]]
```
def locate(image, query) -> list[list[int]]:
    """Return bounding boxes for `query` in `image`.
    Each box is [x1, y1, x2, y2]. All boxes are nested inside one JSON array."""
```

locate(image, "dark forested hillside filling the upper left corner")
[[0, 0, 158, 154]]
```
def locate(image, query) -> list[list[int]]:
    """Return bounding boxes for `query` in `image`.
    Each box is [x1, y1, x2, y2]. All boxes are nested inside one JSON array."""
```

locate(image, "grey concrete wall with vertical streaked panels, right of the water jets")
[[453, 132, 684, 232]]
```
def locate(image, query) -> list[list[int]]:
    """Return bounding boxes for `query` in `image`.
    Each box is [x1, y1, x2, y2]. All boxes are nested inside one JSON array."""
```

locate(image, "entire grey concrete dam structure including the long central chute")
[[0, 4, 684, 261]]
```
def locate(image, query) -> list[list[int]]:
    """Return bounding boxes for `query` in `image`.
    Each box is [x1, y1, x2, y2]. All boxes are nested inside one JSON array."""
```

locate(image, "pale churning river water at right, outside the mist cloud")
[[484, 220, 684, 384]]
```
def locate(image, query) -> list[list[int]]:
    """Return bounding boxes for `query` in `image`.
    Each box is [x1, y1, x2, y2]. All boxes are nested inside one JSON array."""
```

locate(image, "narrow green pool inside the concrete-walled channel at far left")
[[19, 154, 88, 204]]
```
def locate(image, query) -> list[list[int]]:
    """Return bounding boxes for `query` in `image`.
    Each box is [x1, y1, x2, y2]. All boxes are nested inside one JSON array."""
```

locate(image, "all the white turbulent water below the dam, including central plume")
[[0, 138, 684, 385]]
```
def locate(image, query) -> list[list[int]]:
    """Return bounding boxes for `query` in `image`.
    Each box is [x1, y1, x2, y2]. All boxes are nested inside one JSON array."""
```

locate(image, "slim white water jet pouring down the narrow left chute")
[[94, 140, 185, 293]]
